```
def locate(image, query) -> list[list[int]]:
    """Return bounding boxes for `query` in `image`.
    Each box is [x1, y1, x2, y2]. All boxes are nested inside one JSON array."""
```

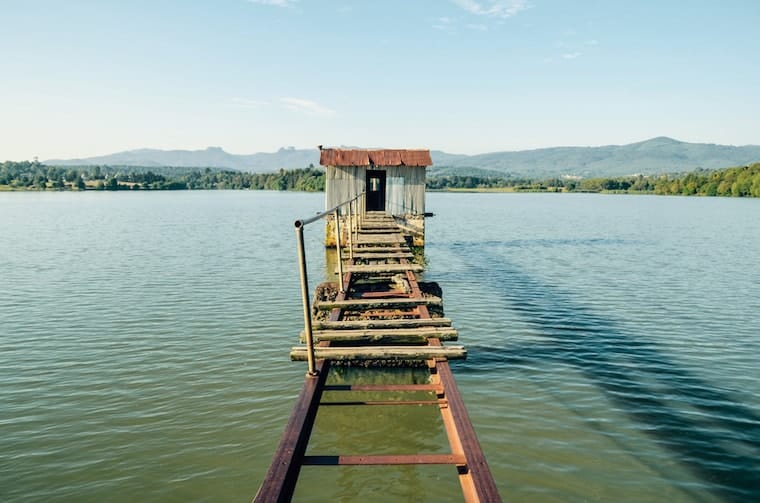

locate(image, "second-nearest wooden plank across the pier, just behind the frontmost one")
[[301, 327, 458, 344]]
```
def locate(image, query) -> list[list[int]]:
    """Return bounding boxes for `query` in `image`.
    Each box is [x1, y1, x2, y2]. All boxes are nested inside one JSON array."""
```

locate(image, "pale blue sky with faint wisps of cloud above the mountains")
[[0, 0, 760, 161]]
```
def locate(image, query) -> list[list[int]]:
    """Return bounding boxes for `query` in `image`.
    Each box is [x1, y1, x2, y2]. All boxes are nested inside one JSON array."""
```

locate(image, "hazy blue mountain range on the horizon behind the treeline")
[[45, 137, 760, 178]]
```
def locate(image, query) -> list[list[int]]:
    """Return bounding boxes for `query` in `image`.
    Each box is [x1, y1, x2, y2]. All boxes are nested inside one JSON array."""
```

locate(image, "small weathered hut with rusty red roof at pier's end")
[[319, 147, 433, 246]]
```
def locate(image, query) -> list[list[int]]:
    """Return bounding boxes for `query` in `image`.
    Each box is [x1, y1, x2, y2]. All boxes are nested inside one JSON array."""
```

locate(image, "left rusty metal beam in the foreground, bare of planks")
[[253, 360, 330, 503]]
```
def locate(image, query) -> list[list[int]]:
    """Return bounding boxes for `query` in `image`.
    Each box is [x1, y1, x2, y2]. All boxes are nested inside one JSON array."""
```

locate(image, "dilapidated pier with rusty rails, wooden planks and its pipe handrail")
[[254, 206, 501, 503]]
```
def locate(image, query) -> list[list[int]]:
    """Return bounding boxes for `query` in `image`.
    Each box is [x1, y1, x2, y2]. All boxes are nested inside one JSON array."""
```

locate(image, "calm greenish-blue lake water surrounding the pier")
[[0, 192, 760, 502]]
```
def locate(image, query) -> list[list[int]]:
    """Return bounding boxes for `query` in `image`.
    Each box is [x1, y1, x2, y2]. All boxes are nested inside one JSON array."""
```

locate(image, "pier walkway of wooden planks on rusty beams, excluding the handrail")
[[254, 210, 501, 503]]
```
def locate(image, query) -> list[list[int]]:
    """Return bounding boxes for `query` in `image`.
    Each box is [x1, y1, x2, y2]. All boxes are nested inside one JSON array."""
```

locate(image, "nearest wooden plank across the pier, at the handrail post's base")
[[290, 346, 467, 361]]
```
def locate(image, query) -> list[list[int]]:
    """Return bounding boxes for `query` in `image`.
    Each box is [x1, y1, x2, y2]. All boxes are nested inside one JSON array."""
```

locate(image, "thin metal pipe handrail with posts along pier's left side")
[[295, 192, 366, 377]]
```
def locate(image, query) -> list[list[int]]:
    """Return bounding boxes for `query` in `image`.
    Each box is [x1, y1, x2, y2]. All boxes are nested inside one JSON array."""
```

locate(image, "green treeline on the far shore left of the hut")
[[0, 161, 325, 192]]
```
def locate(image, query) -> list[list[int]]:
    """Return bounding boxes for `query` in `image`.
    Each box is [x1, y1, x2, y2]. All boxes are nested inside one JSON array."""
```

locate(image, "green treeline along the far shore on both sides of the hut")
[[0, 161, 760, 197]]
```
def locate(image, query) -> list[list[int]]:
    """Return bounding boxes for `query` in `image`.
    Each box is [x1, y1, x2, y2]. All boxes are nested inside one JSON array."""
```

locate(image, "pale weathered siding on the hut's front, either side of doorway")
[[325, 166, 425, 215]]
